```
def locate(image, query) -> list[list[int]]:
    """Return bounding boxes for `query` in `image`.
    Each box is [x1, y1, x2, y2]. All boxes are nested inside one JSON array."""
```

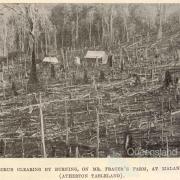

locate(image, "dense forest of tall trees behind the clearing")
[[0, 4, 180, 58]]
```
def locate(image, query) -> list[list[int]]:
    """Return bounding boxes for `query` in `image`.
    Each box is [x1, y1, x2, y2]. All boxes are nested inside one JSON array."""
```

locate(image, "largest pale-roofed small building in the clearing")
[[84, 51, 108, 66]]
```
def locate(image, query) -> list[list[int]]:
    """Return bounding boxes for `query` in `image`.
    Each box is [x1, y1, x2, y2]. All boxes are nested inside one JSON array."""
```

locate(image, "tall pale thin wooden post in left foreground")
[[39, 94, 47, 158]]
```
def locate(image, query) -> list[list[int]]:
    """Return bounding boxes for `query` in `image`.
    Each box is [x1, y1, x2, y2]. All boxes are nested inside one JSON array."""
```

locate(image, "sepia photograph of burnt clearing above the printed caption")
[[0, 3, 180, 158]]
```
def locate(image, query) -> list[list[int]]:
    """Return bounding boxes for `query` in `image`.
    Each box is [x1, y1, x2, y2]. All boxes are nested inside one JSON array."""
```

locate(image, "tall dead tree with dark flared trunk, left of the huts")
[[3, 4, 53, 92]]
